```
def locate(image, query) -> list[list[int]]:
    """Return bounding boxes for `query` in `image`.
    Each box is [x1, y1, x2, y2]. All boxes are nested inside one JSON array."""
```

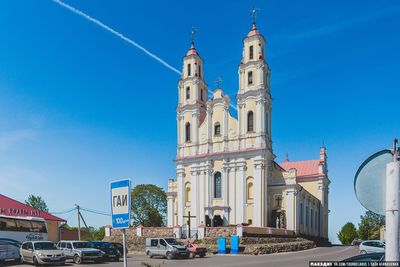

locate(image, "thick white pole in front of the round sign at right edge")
[[385, 139, 400, 261]]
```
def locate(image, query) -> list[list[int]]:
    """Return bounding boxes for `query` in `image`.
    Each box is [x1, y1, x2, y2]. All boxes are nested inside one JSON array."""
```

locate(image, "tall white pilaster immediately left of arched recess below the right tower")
[[236, 159, 246, 224]]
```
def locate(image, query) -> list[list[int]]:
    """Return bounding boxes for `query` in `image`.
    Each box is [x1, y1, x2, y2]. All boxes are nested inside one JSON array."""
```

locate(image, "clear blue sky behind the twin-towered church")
[[0, 0, 400, 244]]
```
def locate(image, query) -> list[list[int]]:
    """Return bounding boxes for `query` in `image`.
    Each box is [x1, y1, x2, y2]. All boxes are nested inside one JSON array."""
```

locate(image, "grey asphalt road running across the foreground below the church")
[[9, 246, 358, 267]]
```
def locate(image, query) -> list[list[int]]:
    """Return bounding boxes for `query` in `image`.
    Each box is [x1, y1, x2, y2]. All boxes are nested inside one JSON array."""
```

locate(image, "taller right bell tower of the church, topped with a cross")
[[237, 9, 272, 149]]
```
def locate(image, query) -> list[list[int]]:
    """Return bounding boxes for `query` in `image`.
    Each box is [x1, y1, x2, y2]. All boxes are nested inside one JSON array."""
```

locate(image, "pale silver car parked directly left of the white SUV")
[[20, 241, 65, 266]]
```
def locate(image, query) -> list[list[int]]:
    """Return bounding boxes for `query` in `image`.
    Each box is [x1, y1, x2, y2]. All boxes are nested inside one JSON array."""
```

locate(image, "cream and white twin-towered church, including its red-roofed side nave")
[[167, 22, 330, 238]]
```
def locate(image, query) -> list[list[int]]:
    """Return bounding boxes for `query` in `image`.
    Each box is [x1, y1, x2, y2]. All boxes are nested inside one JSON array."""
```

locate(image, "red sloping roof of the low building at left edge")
[[0, 194, 65, 222]]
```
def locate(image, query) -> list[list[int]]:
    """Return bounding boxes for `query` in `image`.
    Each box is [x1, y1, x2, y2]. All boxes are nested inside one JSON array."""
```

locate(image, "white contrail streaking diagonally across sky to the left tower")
[[53, 0, 181, 75]]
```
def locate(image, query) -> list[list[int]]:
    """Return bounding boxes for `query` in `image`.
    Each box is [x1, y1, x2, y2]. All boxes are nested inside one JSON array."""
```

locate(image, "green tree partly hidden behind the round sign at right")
[[358, 211, 385, 240]]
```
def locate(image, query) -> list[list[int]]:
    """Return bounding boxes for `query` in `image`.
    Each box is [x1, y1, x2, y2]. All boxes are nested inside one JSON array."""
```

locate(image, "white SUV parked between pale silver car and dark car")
[[57, 240, 104, 264]]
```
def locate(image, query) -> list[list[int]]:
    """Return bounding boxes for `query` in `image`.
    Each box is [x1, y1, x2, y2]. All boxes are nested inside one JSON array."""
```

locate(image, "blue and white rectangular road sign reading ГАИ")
[[110, 179, 131, 229]]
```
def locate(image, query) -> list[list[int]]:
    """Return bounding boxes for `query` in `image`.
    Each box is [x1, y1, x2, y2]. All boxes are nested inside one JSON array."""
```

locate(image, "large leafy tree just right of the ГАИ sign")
[[131, 184, 167, 226]]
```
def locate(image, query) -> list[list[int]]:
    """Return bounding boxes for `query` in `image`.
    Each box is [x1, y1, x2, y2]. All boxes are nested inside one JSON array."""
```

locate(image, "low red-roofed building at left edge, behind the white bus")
[[0, 194, 66, 242]]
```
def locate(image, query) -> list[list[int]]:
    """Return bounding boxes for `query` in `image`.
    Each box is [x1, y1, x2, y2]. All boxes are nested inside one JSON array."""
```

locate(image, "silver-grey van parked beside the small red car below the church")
[[146, 238, 189, 260]]
